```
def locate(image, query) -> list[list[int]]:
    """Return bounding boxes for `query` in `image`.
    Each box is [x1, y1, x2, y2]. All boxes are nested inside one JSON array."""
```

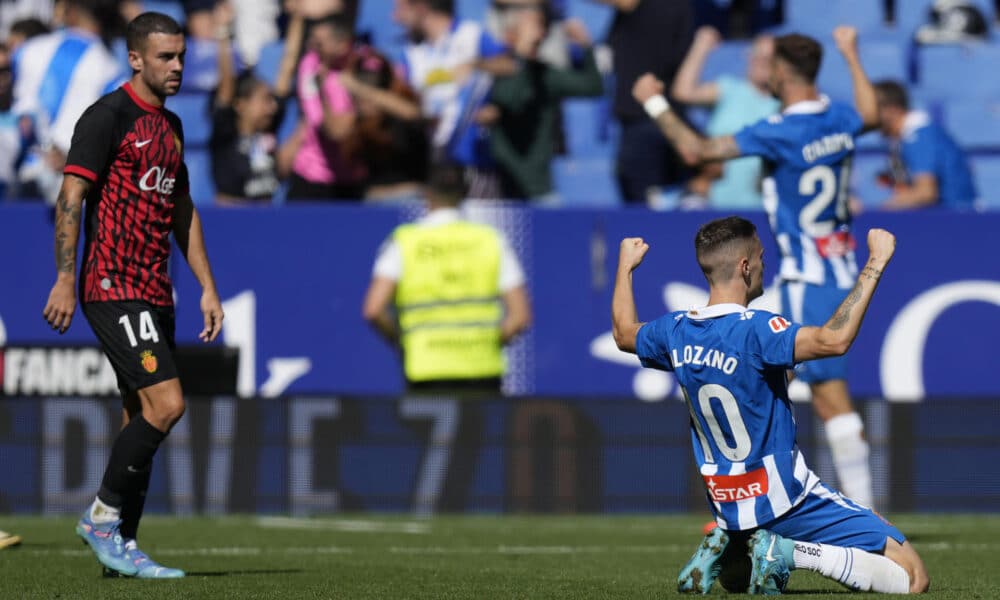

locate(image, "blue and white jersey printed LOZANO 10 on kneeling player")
[[636, 304, 819, 530]]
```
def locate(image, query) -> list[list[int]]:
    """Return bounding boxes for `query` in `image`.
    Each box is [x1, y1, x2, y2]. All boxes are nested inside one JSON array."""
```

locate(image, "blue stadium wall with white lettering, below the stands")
[[0, 204, 1000, 402]]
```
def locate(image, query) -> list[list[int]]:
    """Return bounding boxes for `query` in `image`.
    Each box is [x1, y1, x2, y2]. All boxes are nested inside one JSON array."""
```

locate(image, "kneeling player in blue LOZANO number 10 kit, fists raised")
[[612, 217, 929, 594]]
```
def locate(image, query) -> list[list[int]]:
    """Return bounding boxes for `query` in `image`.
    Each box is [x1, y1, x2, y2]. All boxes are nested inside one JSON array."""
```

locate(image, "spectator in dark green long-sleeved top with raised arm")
[[490, 6, 603, 204]]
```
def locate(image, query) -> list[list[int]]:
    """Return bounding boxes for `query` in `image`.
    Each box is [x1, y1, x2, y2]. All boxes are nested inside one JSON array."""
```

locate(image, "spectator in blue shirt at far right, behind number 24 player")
[[875, 80, 977, 209]]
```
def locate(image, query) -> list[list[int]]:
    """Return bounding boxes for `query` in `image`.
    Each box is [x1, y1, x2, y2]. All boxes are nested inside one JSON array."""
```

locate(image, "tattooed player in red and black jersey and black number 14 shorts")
[[44, 13, 223, 578]]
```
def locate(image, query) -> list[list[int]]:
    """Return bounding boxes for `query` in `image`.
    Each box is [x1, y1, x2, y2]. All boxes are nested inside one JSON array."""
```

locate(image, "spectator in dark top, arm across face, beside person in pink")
[[341, 47, 429, 202]]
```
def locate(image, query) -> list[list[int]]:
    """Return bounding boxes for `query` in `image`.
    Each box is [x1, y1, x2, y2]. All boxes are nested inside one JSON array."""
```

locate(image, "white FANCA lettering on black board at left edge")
[[0, 346, 118, 396]]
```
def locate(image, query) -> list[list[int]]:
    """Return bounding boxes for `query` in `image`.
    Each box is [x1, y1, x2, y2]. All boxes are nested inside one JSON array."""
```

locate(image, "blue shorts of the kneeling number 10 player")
[[761, 483, 906, 554]]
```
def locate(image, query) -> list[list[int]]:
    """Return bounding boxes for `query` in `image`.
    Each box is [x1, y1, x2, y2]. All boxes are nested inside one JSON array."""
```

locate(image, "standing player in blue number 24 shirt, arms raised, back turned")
[[632, 27, 878, 506]]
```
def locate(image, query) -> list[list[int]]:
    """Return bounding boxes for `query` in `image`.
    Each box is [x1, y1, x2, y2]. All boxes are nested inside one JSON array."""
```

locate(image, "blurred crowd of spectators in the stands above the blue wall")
[[0, 0, 1000, 209]]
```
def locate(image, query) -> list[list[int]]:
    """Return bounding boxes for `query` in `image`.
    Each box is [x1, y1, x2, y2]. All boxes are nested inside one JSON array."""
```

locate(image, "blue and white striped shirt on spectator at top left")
[[12, 29, 126, 153]]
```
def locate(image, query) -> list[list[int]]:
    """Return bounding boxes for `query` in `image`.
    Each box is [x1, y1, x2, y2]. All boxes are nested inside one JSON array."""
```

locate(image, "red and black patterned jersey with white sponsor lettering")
[[64, 83, 188, 306]]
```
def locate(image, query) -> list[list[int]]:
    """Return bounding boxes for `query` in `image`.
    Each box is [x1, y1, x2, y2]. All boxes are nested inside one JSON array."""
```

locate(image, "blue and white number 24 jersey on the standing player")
[[735, 97, 862, 289]]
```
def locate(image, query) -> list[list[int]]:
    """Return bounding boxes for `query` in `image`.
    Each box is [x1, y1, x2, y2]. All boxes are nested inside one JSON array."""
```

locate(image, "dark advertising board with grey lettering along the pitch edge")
[[0, 396, 1000, 515]]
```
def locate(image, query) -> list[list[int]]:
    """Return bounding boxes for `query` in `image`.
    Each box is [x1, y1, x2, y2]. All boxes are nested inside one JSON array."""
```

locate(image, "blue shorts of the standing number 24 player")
[[779, 281, 850, 383]]
